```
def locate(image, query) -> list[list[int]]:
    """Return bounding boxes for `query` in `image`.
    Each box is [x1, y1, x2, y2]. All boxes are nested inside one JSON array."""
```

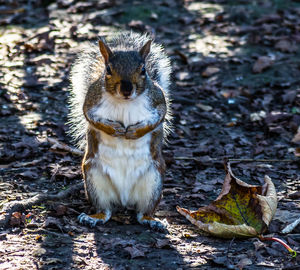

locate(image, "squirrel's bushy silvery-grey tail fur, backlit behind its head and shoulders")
[[68, 32, 171, 148]]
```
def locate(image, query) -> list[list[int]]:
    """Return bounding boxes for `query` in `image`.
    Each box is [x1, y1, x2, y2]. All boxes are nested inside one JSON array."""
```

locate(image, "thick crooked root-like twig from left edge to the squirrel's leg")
[[0, 183, 83, 227]]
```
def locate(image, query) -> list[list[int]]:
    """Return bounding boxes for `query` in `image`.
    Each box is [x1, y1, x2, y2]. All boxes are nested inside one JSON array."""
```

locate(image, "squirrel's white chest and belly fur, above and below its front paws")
[[92, 90, 157, 206]]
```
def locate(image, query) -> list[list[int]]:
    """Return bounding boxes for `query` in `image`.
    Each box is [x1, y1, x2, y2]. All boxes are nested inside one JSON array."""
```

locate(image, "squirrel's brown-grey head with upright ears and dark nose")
[[99, 40, 151, 99]]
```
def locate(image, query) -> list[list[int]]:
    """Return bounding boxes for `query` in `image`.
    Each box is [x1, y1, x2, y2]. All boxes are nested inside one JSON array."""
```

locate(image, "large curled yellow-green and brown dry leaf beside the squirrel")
[[177, 162, 277, 238]]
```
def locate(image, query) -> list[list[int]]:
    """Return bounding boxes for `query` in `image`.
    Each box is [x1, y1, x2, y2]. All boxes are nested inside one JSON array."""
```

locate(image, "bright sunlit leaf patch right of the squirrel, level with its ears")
[[189, 33, 232, 57]]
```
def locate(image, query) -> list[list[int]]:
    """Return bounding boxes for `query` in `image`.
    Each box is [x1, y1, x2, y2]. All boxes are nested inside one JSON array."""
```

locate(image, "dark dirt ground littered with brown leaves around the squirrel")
[[0, 0, 300, 269]]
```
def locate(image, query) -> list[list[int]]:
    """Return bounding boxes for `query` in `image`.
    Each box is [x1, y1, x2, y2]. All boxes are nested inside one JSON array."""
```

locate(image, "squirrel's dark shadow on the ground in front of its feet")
[[94, 215, 185, 269]]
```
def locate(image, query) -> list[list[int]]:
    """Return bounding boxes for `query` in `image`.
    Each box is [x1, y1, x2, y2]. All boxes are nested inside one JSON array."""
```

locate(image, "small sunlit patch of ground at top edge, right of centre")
[[186, 2, 224, 19]]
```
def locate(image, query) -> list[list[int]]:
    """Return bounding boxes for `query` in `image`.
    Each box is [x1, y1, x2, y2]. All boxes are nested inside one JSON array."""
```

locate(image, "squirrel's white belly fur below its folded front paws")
[[99, 132, 152, 206]]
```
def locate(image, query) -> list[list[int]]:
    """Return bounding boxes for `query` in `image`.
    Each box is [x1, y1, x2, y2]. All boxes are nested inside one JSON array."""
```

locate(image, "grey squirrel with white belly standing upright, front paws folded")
[[69, 32, 171, 229]]
